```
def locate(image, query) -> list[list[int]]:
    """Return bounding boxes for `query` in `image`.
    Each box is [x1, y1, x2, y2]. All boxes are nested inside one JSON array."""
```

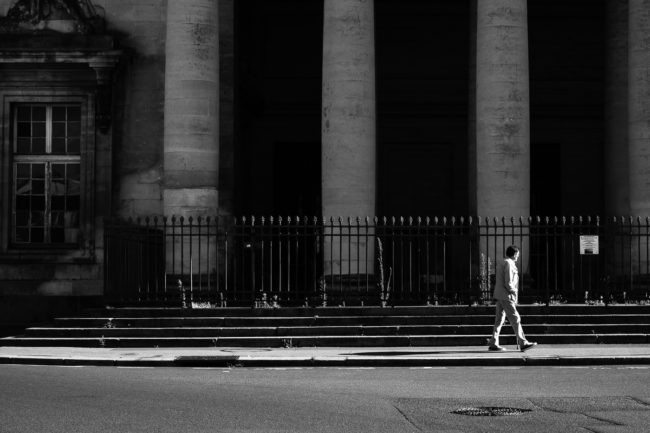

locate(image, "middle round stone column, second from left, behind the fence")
[[321, 0, 376, 280]]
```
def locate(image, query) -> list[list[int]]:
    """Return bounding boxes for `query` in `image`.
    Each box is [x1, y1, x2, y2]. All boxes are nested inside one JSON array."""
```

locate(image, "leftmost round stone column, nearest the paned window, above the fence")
[[163, 0, 219, 216]]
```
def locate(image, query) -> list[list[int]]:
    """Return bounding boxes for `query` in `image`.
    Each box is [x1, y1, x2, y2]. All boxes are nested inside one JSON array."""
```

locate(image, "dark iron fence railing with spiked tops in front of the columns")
[[104, 217, 650, 306]]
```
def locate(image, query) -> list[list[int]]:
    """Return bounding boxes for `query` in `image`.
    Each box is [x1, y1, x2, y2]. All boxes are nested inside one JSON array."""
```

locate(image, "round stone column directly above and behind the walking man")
[[468, 0, 530, 272]]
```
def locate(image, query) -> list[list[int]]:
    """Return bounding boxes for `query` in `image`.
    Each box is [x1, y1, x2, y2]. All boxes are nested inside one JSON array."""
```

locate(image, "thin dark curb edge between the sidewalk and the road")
[[0, 355, 650, 368]]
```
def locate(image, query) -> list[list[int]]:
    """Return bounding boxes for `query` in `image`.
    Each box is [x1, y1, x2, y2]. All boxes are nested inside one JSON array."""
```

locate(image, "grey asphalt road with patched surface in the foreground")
[[0, 365, 650, 433]]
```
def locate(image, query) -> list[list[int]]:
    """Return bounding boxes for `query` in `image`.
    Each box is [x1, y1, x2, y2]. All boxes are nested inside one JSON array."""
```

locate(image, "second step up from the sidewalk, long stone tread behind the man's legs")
[[25, 323, 650, 338]]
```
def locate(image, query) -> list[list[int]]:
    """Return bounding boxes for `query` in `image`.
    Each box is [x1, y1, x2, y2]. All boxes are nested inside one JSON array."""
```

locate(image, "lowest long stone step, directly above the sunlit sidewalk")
[[0, 333, 650, 348]]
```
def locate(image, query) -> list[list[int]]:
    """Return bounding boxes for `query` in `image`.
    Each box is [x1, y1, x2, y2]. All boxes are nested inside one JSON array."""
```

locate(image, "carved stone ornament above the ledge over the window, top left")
[[0, 0, 104, 34]]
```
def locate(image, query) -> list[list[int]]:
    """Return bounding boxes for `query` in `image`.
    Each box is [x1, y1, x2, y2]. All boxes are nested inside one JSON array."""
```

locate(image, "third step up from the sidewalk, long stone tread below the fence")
[[48, 314, 650, 328]]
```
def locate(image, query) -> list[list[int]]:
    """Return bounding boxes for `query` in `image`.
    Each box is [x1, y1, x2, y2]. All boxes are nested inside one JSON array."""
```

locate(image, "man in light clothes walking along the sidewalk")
[[488, 245, 537, 352]]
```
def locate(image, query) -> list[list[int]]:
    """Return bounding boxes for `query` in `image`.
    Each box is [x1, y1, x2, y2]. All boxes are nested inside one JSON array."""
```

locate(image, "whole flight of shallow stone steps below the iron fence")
[[0, 305, 650, 347]]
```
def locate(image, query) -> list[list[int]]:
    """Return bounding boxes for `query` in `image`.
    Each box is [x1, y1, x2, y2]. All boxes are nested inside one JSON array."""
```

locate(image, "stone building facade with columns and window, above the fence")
[[0, 0, 650, 323]]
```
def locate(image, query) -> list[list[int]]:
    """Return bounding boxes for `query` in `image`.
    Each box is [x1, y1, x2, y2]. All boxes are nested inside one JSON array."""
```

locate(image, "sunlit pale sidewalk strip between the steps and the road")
[[0, 344, 650, 367]]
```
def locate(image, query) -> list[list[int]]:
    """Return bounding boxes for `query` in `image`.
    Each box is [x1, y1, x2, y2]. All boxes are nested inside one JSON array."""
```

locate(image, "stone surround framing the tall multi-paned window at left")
[[0, 89, 96, 261]]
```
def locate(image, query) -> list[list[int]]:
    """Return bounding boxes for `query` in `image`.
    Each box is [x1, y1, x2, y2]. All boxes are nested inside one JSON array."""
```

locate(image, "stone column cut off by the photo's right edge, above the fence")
[[628, 0, 650, 217]]
